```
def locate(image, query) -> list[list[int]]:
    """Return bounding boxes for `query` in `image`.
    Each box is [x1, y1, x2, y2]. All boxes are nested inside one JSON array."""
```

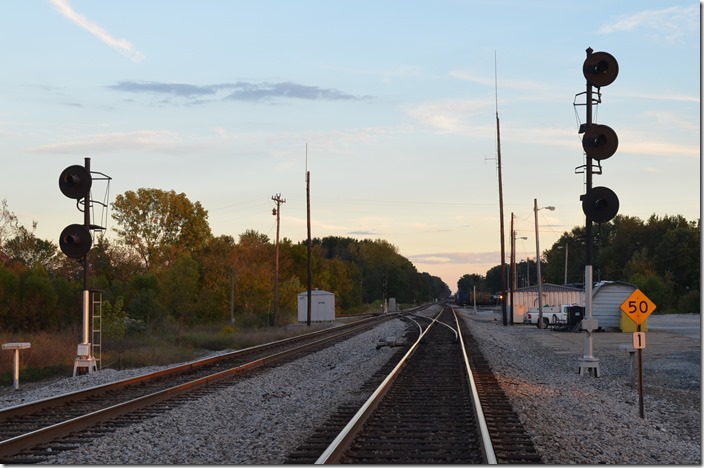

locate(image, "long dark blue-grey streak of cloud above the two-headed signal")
[[108, 81, 370, 102]]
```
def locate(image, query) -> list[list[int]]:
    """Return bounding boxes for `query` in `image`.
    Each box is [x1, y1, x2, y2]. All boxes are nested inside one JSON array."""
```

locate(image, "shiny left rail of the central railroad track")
[[315, 309, 434, 465]]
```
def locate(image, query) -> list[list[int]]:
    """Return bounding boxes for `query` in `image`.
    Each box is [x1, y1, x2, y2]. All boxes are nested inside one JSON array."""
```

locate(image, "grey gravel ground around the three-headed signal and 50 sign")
[[463, 311, 701, 465]]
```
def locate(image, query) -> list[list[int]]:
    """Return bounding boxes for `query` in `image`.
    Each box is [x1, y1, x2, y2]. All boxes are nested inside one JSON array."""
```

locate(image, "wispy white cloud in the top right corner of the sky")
[[597, 5, 699, 42]]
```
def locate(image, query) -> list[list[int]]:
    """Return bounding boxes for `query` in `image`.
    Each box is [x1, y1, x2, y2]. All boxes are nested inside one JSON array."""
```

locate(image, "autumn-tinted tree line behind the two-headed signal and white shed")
[[0, 192, 450, 335]]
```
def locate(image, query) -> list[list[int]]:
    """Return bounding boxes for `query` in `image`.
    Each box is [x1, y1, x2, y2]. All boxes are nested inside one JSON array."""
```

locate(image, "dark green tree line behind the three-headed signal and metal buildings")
[[457, 214, 701, 313]]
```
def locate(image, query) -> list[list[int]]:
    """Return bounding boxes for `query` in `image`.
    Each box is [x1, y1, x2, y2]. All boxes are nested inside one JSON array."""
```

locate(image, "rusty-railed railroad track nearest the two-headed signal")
[[0, 311, 418, 464]]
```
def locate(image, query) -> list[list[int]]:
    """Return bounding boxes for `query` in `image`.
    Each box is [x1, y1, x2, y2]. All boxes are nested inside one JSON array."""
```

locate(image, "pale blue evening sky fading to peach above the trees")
[[0, 0, 701, 291]]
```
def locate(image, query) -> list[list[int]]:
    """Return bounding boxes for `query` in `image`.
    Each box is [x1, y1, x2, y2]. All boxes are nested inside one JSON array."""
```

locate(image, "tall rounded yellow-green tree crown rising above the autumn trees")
[[112, 188, 212, 271]]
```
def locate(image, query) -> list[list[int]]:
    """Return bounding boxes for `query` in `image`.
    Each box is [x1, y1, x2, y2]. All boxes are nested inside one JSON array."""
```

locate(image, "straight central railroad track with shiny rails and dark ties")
[[287, 307, 541, 464]]
